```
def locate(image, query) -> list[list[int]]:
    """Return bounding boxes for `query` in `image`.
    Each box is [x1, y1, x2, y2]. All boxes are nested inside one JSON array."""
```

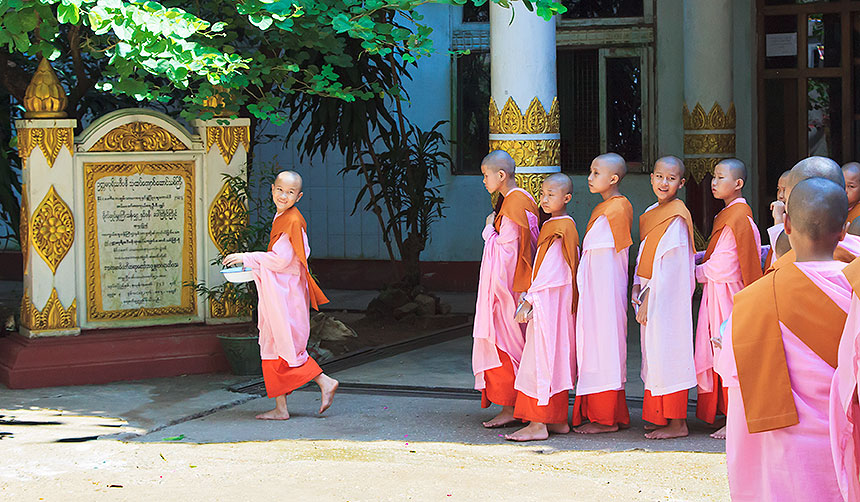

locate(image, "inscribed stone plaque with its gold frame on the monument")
[[84, 161, 197, 321]]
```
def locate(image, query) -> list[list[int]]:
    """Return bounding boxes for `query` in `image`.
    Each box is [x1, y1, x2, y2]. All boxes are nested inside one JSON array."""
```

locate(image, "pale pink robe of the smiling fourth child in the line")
[[633, 208, 696, 396]]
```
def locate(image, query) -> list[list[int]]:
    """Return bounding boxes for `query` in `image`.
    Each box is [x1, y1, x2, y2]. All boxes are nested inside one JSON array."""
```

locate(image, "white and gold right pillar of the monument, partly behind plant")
[[194, 118, 251, 324]]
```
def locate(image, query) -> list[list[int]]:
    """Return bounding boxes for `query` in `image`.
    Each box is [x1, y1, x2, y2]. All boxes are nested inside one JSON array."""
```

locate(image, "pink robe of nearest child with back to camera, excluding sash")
[[716, 261, 851, 502]]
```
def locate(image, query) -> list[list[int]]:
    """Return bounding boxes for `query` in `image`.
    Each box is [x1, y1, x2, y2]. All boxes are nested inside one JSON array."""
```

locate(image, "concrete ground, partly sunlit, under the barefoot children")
[[0, 288, 728, 501]]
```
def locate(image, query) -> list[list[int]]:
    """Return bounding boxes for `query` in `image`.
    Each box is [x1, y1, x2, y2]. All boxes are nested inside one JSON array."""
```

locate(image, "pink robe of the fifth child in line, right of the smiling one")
[[695, 198, 761, 392]]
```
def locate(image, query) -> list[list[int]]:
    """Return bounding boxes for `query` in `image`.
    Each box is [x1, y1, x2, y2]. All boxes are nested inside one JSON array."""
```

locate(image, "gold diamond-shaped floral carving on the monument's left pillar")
[[30, 185, 75, 273]]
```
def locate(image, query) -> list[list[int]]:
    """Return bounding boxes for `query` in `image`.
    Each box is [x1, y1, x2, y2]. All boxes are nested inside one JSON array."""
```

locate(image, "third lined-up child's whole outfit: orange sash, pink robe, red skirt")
[[572, 196, 633, 426]]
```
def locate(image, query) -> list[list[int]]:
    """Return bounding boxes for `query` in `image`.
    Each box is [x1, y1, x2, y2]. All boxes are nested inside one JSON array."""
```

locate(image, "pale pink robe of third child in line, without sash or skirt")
[[576, 215, 629, 396]]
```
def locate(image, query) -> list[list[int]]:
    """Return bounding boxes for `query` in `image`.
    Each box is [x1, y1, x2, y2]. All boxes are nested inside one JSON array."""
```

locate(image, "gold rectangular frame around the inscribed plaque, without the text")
[[84, 161, 197, 321]]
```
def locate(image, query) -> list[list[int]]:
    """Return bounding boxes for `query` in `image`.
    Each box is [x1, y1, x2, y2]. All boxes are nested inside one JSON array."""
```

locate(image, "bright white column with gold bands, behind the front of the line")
[[489, 2, 561, 197]]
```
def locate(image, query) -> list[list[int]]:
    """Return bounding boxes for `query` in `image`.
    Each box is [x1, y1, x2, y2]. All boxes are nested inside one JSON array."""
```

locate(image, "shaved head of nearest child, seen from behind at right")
[[788, 178, 848, 246]]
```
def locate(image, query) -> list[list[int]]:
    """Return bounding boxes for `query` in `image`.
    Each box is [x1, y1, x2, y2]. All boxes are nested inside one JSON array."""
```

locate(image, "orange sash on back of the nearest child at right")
[[731, 266, 847, 433]]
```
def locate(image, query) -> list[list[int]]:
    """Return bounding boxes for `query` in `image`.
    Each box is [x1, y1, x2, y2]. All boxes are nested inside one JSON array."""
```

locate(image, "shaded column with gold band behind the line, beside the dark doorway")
[[683, 0, 735, 183]]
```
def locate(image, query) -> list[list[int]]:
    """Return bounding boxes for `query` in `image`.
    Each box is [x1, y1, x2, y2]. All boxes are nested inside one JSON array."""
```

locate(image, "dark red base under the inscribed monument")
[[0, 324, 239, 389]]
